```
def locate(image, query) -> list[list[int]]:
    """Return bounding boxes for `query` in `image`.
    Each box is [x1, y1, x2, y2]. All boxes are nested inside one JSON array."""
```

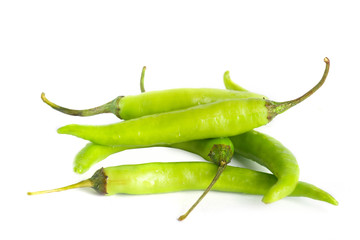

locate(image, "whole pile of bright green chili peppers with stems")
[[28, 58, 338, 220]]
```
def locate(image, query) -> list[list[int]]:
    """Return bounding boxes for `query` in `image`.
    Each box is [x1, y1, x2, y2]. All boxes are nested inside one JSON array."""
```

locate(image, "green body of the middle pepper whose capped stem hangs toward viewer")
[[74, 138, 234, 173]]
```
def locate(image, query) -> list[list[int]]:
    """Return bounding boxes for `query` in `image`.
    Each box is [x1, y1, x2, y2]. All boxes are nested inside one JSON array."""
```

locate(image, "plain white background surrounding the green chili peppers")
[[0, 0, 360, 239]]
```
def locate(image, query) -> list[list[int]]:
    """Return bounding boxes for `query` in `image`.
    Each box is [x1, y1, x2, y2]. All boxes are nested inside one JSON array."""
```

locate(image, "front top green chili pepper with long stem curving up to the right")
[[58, 58, 330, 146]]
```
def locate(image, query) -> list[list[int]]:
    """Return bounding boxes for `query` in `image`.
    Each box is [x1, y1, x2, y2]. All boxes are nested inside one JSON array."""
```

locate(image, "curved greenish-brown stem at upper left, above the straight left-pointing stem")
[[41, 93, 122, 117]]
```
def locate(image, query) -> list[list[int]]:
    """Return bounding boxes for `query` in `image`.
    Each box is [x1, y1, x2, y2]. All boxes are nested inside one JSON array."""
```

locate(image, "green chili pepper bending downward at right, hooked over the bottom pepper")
[[230, 130, 300, 203]]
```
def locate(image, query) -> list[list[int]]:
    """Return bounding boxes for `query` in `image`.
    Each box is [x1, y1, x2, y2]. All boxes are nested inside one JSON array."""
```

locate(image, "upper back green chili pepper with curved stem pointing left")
[[41, 88, 263, 120]]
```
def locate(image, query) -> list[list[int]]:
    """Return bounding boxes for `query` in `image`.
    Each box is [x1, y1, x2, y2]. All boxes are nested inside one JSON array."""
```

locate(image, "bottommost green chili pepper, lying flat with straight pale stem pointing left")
[[28, 162, 338, 205]]
